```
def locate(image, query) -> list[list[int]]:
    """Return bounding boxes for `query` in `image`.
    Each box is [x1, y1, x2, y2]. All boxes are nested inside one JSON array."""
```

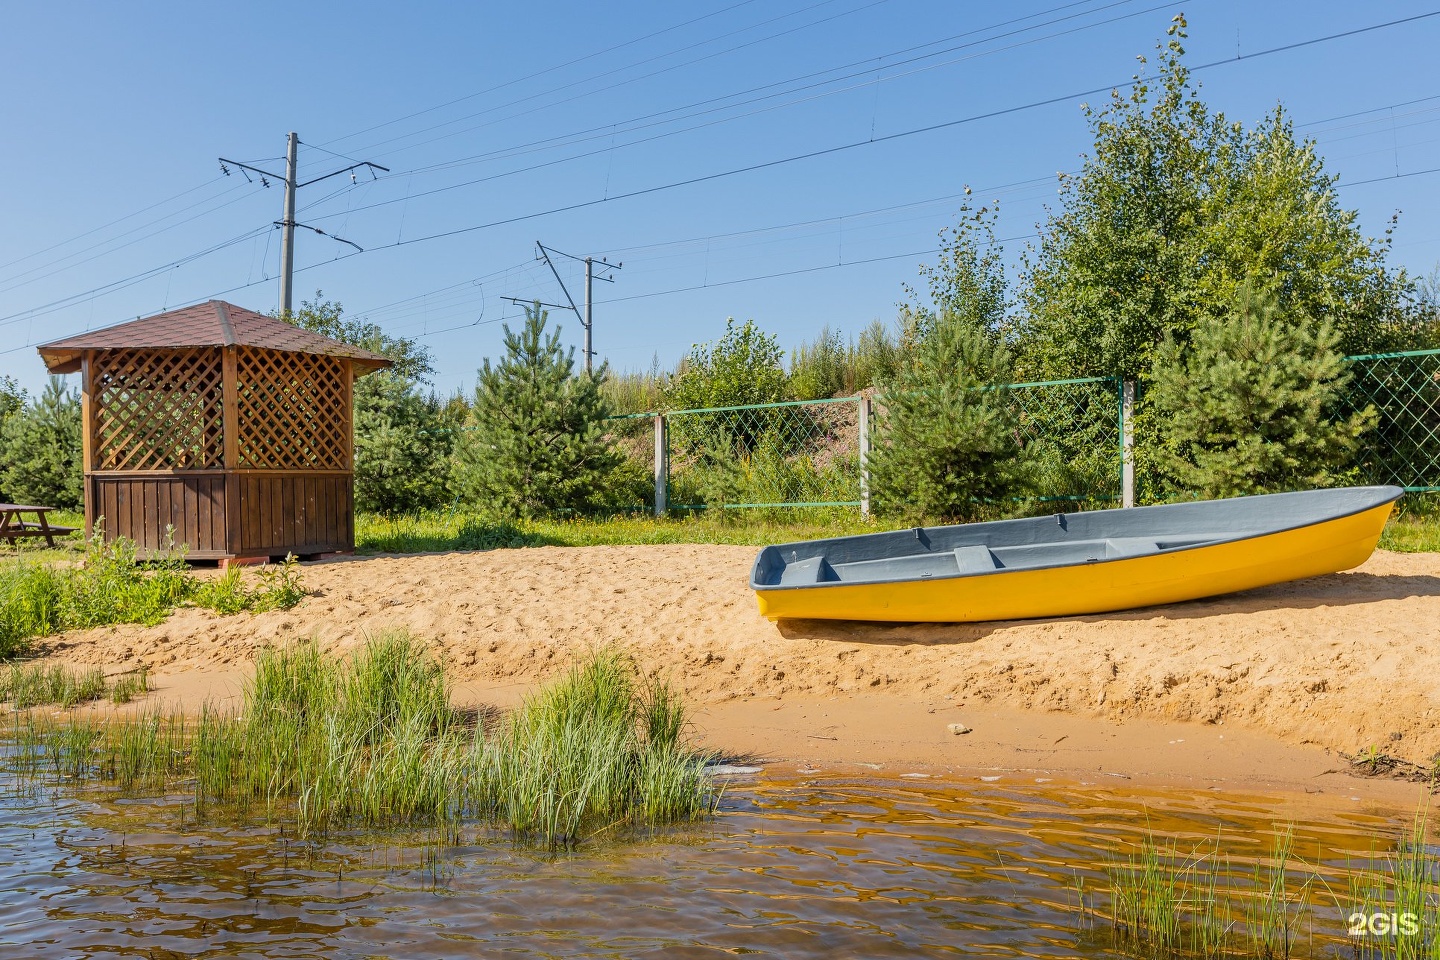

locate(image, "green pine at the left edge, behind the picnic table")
[[0, 377, 85, 508]]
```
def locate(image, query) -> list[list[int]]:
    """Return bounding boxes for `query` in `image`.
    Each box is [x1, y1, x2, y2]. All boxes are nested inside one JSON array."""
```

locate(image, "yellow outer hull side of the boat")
[[756, 502, 1391, 623]]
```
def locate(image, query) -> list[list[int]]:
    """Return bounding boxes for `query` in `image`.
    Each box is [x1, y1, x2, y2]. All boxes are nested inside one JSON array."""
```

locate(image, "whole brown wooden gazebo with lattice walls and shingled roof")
[[39, 299, 390, 563]]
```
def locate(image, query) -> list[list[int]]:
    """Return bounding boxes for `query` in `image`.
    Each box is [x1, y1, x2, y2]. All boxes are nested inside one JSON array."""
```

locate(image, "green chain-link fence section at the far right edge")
[[1348, 350, 1440, 491]]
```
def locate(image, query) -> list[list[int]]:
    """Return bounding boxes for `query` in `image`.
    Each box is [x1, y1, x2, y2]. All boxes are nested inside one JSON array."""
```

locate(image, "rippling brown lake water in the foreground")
[[0, 770, 1404, 959]]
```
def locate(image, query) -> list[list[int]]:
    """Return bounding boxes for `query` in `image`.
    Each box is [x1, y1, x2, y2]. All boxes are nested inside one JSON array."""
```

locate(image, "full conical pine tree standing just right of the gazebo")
[[456, 304, 622, 517]]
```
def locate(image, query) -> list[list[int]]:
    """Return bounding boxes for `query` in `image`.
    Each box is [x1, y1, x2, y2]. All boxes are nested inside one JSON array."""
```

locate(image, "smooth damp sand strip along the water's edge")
[[35, 671, 1431, 815]]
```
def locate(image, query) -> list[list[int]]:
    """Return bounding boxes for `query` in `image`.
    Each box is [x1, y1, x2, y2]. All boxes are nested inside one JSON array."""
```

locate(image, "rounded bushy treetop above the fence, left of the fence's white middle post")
[[665, 317, 791, 410]]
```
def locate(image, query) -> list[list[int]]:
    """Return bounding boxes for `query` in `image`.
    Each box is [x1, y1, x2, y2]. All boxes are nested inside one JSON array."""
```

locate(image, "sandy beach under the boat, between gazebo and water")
[[30, 545, 1440, 800]]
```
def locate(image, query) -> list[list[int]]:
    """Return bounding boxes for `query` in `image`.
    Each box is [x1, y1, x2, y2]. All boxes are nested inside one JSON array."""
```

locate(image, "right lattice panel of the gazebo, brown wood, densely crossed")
[[236, 350, 350, 471]]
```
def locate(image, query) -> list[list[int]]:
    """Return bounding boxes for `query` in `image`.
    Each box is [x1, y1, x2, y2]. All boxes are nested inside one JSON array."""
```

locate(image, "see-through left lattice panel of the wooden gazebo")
[[91, 348, 225, 471]]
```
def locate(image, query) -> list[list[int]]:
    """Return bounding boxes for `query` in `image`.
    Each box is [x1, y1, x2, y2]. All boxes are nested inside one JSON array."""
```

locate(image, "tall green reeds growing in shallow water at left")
[[2, 632, 717, 848]]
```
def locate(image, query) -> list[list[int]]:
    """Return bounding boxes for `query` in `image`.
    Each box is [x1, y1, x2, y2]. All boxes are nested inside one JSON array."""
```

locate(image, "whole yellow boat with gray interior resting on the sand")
[[750, 486, 1403, 623]]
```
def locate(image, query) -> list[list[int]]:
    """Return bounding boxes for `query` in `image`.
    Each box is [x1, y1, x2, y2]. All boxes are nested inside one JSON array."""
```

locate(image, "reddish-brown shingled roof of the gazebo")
[[37, 299, 390, 373]]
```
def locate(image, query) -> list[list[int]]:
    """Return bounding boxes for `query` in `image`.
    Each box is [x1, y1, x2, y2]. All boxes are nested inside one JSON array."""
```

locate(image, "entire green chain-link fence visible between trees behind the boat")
[[452, 350, 1440, 511]]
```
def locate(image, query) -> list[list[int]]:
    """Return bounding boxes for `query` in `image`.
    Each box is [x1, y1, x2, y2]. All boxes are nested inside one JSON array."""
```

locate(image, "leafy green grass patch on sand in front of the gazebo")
[[0, 533, 305, 659]]
